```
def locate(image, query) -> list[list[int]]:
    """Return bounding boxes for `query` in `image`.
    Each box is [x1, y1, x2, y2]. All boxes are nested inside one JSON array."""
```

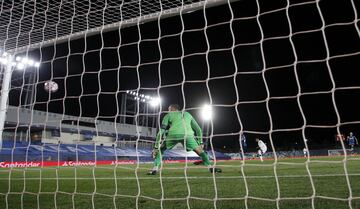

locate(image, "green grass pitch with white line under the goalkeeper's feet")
[[0, 157, 360, 209]]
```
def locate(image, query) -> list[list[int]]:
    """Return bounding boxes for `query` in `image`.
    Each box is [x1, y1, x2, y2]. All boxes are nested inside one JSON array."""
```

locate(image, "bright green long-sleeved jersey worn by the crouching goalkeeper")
[[155, 111, 202, 148]]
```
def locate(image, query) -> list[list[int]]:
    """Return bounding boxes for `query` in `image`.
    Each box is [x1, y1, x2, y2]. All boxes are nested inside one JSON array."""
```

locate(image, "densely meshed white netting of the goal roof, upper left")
[[0, 0, 222, 51]]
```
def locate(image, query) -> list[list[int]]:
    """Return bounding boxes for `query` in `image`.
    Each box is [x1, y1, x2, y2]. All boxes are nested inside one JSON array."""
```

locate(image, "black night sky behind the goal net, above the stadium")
[[7, 0, 360, 150]]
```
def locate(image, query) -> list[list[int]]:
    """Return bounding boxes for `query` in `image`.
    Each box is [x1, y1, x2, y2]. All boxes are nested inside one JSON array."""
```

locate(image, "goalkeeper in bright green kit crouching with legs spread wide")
[[148, 104, 221, 175]]
